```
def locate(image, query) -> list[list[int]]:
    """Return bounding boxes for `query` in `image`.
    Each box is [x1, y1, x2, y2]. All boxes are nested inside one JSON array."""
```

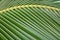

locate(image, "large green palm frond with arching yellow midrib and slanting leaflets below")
[[0, 5, 60, 40]]
